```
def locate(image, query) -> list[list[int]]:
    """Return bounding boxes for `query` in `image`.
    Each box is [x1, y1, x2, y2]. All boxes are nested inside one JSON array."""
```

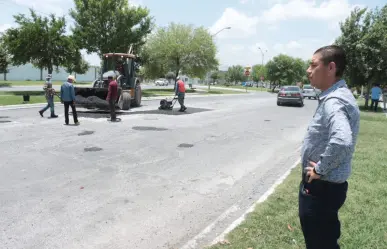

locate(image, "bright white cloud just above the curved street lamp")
[[210, 8, 258, 38]]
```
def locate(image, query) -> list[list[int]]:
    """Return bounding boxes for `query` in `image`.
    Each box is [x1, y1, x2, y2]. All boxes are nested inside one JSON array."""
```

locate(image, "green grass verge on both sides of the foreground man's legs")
[[210, 108, 387, 249]]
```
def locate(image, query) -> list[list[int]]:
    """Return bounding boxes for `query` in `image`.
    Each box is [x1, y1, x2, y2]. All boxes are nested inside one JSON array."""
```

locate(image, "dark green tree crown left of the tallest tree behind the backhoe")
[[4, 10, 73, 74]]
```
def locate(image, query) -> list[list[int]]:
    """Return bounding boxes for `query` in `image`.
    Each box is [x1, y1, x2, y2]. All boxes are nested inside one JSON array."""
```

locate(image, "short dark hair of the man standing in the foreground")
[[314, 45, 347, 77]]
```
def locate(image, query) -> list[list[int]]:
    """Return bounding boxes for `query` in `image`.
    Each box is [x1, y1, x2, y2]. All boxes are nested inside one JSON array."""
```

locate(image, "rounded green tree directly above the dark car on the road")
[[266, 54, 306, 91]]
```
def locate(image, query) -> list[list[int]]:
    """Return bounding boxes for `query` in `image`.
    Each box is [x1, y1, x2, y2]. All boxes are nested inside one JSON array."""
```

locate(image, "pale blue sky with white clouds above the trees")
[[0, 0, 386, 70]]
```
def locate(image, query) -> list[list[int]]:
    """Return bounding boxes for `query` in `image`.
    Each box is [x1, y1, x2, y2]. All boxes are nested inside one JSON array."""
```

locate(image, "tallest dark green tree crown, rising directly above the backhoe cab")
[[70, 0, 153, 58]]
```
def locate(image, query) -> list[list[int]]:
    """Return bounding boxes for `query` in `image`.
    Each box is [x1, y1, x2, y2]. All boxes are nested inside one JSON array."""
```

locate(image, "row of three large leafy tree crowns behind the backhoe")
[[0, 0, 218, 82]]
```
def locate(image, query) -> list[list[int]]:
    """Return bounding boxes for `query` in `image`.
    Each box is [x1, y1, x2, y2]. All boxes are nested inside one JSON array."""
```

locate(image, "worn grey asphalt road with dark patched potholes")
[[0, 93, 317, 249]]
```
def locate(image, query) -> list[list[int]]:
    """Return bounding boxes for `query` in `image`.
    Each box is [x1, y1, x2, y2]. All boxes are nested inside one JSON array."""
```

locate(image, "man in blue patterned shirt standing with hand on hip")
[[299, 45, 360, 249]]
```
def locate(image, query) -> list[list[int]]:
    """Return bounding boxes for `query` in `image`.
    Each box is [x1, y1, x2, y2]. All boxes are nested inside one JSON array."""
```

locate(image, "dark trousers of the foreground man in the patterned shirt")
[[299, 180, 348, 249]]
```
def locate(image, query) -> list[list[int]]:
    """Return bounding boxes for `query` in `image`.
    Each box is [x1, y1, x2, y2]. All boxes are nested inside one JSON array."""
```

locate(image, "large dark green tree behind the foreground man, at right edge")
[[335, 5, 387, 107]]
